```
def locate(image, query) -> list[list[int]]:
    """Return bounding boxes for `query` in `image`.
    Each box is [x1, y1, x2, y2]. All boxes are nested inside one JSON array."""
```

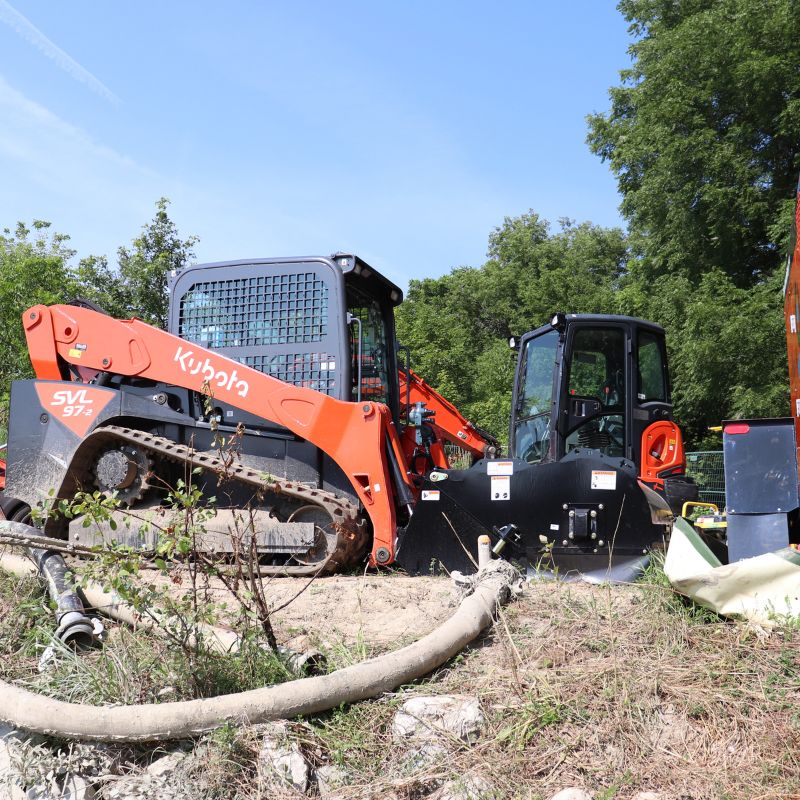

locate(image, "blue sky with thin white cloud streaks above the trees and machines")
[[0, 0, 629, 287]]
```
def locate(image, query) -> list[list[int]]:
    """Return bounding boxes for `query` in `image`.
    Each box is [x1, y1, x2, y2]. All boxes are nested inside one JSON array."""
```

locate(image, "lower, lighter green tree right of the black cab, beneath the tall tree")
[[618, 265, 789, 449]]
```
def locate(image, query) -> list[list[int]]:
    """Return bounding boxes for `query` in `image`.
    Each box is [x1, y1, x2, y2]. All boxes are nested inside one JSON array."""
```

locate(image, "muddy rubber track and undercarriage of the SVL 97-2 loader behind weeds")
[[63, 425, 367, 576]]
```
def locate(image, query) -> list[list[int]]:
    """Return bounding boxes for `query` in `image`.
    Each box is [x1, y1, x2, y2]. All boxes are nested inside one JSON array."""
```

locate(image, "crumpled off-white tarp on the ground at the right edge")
[[664, 517, 800, 624]]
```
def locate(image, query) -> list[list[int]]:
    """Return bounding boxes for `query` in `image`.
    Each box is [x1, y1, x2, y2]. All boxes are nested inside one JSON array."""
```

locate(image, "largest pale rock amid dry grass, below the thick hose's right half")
[[392, 695, 484, 744]]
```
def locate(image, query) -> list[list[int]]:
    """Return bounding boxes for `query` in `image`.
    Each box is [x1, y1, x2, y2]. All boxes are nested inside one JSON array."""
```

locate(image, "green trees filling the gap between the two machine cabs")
[[398, 212, 627, 439]]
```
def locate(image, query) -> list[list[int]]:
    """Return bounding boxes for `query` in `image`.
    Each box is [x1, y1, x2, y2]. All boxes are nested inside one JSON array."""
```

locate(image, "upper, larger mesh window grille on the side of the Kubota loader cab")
[[178, 272, 328, 348]]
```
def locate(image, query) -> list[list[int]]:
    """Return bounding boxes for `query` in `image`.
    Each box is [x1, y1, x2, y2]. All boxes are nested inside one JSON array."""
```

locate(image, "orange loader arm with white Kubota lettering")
[[22, 305, 414, 564]]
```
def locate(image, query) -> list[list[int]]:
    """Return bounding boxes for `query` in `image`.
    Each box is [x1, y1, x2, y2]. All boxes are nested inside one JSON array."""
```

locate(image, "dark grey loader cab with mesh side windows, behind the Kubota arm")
[[169, 253, 403, 422]]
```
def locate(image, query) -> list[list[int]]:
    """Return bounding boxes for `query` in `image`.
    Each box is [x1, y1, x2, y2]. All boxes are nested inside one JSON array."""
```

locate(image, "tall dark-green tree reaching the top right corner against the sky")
[[588, 0, 800, 287]]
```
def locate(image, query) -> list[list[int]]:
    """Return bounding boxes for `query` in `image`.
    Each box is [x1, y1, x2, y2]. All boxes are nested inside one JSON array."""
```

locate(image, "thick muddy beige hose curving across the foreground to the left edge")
[[0, 558, 519, 742]]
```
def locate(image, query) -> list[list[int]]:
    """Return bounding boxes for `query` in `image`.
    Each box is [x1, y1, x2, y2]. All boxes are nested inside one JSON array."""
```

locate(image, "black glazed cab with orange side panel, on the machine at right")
[[510, 314, 683, 483]]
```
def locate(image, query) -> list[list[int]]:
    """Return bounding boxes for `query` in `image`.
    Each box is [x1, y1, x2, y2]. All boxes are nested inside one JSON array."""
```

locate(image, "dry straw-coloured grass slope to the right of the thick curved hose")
[[0, 564, 800, 800]]
